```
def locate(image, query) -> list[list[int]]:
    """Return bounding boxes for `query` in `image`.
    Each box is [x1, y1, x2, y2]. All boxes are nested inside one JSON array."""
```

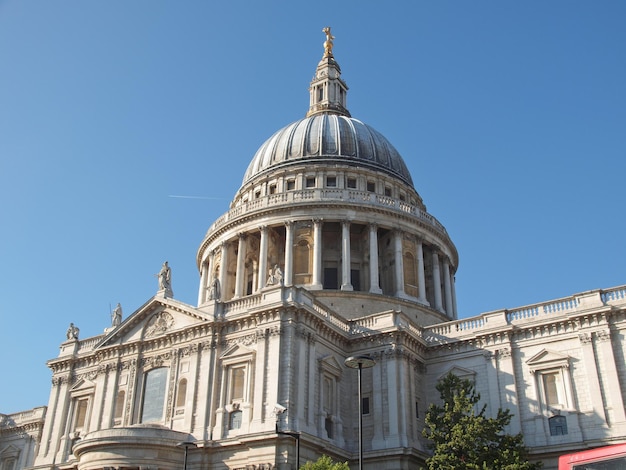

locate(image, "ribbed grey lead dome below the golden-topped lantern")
[[243, 113, 413, 187]]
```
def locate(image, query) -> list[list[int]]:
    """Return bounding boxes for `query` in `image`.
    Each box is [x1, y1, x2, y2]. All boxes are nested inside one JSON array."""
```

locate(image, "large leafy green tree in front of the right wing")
[[422, 373, 541, 470]]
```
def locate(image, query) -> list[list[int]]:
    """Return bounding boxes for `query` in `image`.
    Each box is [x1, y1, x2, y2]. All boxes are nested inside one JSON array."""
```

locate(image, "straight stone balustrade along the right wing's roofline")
[[423, 286, 626, 343]]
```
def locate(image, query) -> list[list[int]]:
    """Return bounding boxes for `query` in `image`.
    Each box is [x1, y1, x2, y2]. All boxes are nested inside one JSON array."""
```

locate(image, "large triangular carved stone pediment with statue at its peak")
[[96, 297, 213, 348]]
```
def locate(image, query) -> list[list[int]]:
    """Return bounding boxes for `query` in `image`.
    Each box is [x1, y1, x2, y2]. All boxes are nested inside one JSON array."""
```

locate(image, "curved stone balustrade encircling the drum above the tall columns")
[[207, 188, 447, 236]]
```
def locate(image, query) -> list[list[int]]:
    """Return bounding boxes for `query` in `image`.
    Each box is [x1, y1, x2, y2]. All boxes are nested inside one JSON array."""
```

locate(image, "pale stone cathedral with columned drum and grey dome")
[[0, 28, 626, 470]]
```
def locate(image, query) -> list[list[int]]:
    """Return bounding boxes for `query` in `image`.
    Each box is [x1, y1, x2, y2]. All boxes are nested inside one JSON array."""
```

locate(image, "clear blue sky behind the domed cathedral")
[[0, 0, 626, 413]]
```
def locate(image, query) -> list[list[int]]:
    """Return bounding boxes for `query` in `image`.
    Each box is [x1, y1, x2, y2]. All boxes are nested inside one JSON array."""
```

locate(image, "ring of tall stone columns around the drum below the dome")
[[198, 219, 457, 318]]
